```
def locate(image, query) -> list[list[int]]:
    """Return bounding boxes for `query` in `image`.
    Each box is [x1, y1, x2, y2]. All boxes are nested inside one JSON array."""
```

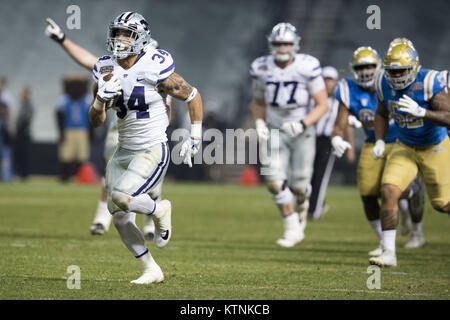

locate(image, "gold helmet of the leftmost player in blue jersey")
[[350, 47, 381, 88]]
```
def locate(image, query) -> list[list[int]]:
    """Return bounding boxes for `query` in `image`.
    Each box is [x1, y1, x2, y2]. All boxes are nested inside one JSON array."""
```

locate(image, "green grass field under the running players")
[[0, 181, 450, 300]]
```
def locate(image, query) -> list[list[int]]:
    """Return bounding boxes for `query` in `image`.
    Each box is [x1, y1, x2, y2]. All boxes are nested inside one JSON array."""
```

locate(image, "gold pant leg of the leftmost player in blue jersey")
[[357, 142, 393, 196]]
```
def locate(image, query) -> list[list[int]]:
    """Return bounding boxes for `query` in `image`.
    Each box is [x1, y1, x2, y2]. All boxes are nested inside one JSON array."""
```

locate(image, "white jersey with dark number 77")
[[250, 53, 325, 128]]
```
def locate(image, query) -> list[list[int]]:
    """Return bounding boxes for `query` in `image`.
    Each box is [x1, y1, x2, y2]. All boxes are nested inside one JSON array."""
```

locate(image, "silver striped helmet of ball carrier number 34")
[[107, 11, 151, 59]]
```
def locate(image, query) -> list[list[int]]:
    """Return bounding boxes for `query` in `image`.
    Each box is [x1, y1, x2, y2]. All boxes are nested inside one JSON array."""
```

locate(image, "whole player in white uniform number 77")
[[250, 22, 328, 247]]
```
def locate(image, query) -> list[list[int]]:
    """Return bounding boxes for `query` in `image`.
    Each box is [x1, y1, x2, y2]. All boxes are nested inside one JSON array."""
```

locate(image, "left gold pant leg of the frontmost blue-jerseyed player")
[[381, 142, 419, 191]]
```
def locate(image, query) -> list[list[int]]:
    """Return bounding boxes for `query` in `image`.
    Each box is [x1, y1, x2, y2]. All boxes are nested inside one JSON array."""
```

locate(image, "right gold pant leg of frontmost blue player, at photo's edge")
[[416, 137, 450, 208]]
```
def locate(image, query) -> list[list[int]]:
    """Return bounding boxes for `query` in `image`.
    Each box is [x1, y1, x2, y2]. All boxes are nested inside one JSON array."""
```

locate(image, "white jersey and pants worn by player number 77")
[[250, 54, 325, 195]]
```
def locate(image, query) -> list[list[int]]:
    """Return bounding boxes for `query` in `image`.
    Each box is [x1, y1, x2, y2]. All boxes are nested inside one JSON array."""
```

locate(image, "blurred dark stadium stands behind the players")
[[0, 0, 450, 184]]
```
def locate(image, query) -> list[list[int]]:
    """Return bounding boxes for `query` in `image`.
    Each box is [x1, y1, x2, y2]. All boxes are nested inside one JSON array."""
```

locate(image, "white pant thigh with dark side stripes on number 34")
[[113, 143, 170, 196]]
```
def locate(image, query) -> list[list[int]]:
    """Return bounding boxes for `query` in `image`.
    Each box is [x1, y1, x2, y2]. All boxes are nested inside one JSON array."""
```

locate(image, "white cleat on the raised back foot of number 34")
[[153, 200, 172, 248]]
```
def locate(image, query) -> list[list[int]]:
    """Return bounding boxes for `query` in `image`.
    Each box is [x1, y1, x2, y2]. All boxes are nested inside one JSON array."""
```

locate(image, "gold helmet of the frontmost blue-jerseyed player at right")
[[384, 38, 421, 90]]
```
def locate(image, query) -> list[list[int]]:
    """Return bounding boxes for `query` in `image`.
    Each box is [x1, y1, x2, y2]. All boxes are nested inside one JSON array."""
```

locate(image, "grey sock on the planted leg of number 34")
[[113, 211, 148, 257]]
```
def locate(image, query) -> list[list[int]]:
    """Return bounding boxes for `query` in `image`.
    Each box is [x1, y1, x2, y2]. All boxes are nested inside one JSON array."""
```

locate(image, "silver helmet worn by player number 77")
[[267, 22, 301, 62]]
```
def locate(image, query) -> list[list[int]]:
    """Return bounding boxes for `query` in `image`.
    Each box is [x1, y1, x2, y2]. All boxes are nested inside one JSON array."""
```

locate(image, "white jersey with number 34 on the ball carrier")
[[93, 46, 175, 150]]
